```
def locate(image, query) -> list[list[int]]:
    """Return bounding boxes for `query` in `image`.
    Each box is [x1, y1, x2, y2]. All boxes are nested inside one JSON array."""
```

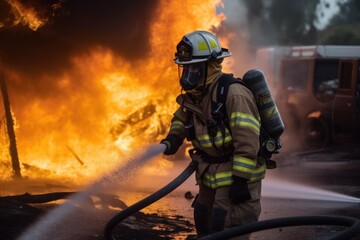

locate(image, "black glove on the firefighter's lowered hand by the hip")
[[229, 176, 251, 204]]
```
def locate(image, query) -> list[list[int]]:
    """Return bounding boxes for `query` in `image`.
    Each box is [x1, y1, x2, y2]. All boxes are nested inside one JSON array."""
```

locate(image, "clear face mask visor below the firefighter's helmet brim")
[[178, 62, 206, 91]]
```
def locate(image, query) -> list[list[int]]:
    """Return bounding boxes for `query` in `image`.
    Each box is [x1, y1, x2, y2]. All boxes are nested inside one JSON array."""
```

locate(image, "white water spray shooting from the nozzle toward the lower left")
[[18, 144, 165, 240]]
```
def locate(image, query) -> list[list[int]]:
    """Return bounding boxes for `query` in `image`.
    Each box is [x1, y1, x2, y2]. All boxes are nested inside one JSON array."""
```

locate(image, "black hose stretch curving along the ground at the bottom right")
[[199, 216, 360, 240]]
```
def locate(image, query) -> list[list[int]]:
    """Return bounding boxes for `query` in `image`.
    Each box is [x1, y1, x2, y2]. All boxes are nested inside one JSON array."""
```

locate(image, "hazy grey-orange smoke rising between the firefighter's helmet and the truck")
[[216, 0, 300, 151]]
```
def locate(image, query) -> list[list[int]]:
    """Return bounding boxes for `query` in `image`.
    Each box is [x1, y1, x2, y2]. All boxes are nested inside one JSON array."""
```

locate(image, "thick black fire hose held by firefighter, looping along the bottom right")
[[104, 161, 360, 240]]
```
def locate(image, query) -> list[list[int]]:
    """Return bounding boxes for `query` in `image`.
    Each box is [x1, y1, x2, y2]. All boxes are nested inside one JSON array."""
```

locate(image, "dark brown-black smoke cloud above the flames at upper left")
[[0, 0, 158, 82]]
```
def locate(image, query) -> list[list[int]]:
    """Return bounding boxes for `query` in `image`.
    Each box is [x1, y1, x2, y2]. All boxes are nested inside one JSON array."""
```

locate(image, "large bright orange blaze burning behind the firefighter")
[[0, 0, 231, 190]]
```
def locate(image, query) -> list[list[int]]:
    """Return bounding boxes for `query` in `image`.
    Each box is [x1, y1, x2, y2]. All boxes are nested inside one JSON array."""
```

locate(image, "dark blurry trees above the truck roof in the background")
[[239, 0, 360, 46]]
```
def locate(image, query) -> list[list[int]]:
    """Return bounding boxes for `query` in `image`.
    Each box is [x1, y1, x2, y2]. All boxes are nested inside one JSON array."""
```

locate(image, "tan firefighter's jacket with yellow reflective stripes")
[[170, 74, 266, 188]]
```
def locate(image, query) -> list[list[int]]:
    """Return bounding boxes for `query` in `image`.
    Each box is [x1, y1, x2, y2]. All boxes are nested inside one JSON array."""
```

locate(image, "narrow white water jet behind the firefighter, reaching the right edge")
[[262, 179, 360, 203]]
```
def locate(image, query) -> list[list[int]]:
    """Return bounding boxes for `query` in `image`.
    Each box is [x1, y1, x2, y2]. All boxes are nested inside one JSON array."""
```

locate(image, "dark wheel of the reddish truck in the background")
[[300, 117, 330, 150]]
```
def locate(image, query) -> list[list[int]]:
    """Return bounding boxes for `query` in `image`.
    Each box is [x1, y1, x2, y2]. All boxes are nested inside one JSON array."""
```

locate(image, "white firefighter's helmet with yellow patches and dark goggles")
[[175, 31, 231, 65]]
